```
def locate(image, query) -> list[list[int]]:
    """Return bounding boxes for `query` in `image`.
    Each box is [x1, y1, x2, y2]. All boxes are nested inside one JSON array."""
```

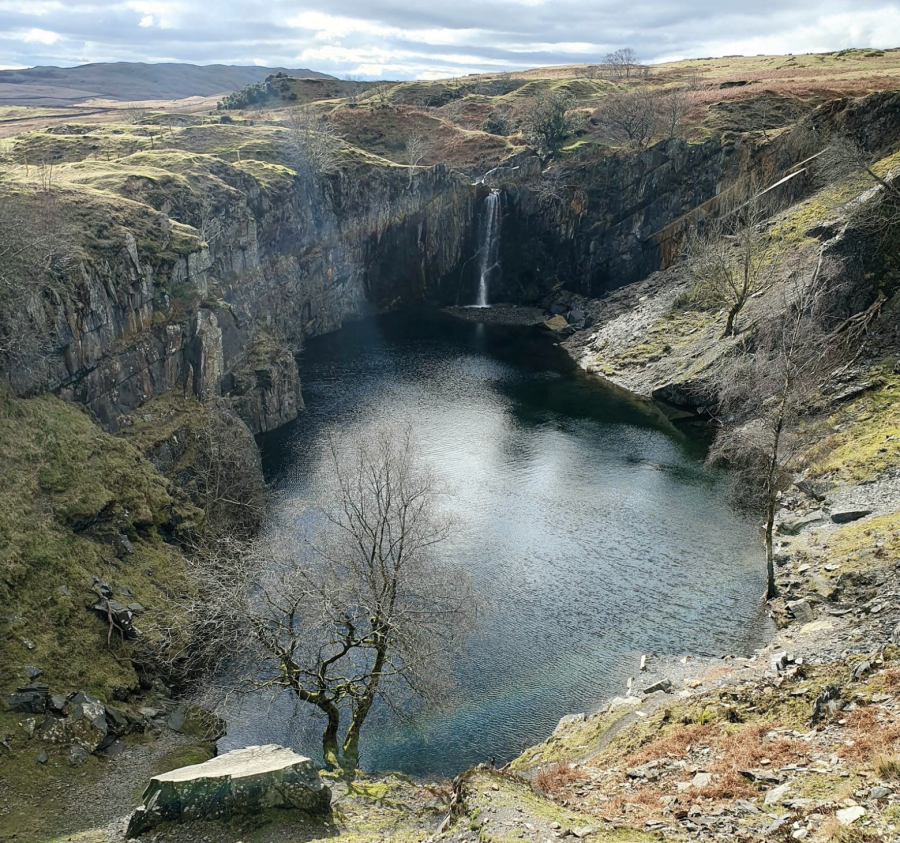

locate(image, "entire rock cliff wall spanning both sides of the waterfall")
[[8, 93, 900, 432]]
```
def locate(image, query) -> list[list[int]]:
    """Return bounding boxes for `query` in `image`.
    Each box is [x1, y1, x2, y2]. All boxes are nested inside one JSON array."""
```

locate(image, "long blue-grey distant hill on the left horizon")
[[0, 62, 332, 105]]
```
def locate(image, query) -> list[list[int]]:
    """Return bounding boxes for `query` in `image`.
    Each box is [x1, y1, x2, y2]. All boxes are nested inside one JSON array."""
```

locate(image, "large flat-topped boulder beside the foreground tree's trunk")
[[127, 744, 331, 837]]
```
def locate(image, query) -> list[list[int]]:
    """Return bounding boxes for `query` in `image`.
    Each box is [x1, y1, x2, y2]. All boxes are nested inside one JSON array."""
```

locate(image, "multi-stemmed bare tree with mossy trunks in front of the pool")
[[171, 430, 472, 769]]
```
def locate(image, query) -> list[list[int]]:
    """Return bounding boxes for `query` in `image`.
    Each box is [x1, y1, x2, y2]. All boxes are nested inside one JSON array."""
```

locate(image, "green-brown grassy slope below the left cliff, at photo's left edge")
[[0, 386, 202, 702]]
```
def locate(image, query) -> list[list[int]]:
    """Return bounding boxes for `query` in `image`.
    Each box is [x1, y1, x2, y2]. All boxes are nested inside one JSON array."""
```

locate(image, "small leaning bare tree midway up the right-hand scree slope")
[[686, 184, 785, 337]]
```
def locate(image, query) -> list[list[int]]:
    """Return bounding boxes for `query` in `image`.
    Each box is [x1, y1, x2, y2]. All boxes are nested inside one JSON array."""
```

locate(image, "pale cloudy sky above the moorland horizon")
[[0, 0, 900, 79]]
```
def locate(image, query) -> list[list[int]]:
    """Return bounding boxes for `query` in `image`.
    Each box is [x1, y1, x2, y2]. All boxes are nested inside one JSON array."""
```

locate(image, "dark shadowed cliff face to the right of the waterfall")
[[486, 92, 900, 300]]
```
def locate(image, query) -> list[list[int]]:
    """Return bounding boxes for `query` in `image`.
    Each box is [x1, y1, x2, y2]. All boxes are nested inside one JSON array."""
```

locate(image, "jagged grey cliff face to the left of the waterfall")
[[7, 156, 474, 432]]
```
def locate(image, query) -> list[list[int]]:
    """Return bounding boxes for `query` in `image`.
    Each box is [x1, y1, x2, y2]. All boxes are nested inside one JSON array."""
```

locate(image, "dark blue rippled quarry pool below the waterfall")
[[223, 313, 765, 774]]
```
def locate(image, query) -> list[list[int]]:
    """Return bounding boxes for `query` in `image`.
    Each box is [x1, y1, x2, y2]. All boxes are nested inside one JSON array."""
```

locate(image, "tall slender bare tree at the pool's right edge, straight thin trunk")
[[710, 253, 834, 599]]
